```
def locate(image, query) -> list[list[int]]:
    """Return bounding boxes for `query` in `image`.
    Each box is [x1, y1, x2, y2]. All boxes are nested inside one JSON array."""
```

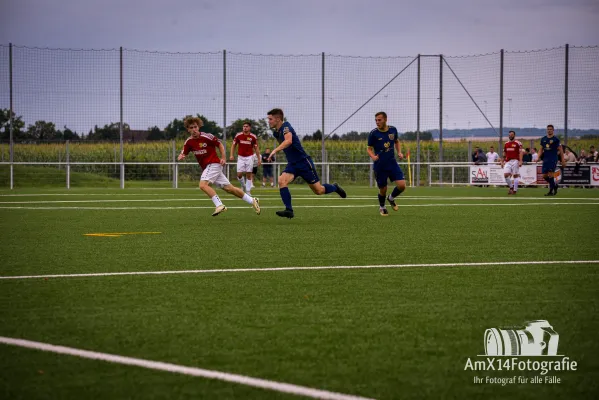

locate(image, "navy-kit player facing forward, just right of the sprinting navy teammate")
[[368, 111, 406, 217]]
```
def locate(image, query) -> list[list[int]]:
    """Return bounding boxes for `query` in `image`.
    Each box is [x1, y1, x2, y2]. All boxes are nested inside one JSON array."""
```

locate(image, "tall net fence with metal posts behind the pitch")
[[0, 45, 599, 186]]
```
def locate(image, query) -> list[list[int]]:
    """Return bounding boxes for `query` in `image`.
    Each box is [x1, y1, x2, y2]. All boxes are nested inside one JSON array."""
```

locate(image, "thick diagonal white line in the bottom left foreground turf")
[[0, 336, 367, 400]]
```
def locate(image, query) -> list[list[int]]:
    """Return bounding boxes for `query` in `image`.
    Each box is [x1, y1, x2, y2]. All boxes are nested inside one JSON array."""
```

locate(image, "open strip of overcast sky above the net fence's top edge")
[[0, 0, 599, 56]]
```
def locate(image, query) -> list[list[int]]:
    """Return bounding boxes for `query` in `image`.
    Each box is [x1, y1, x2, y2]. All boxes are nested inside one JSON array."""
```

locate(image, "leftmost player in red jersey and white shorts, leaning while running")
[[177, 117, 260, 217]]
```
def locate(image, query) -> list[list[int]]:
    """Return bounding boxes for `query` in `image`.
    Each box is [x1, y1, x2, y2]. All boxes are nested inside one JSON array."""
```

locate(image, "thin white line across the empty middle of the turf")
[[0, 260, 599, 279]]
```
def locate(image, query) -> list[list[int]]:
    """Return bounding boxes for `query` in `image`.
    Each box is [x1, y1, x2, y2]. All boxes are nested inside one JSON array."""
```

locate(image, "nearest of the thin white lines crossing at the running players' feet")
[[0, 202, 599, 210]]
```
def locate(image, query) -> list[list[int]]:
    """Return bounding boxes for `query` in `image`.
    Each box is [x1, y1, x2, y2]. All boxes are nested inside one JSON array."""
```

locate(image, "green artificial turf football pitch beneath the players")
[[0, 186, 599, 399]]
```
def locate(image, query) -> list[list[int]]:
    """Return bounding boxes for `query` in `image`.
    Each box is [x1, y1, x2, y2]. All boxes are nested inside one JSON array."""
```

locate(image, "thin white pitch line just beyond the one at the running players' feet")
[[0, 196, 599, 204]]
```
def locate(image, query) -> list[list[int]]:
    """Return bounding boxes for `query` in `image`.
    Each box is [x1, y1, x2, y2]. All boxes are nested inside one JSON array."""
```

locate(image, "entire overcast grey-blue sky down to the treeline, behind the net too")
[[0, 0, 599, 134]]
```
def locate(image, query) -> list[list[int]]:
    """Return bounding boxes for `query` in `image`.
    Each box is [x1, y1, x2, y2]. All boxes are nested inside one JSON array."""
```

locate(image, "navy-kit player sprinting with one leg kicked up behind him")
[[268, 108, 347, 218]]
